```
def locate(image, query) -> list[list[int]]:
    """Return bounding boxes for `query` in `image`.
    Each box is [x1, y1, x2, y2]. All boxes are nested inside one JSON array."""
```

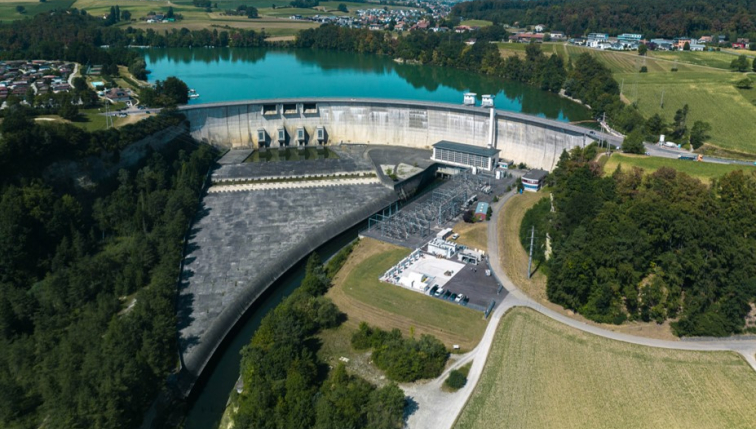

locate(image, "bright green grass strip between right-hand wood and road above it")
[[604, 153, 756, 182]]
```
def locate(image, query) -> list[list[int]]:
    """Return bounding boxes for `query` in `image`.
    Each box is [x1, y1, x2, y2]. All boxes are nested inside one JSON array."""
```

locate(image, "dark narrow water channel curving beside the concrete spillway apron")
[[184, 222, 360, 429]]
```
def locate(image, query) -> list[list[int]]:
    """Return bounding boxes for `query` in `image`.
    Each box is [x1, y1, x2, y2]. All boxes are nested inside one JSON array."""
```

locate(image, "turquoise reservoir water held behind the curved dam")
[[145, 48, 590, 121]]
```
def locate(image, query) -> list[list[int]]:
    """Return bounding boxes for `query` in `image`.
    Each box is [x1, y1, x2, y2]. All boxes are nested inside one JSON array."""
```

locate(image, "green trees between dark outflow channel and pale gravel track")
[[234, 254, 408, 429]]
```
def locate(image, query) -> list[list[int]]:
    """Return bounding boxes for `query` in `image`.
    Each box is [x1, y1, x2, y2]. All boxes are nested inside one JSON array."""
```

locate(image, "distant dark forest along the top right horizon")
[[452, 0, 756, 38]]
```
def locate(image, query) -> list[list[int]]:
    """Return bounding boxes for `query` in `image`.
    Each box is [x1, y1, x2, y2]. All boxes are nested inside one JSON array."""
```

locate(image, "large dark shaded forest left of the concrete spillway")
[[0, 108, 215, 429]]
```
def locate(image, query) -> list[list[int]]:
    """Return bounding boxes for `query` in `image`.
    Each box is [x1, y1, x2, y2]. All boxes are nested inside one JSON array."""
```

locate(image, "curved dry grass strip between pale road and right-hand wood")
[[496, 191, 677, 340]]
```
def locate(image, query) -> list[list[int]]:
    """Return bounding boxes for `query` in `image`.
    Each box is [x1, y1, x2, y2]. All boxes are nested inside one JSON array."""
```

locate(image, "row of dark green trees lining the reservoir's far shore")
[[294, 25, 643, 132]]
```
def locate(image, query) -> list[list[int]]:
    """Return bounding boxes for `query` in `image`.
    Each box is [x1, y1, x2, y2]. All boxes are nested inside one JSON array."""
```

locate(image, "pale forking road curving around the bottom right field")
[[403, 192, 756, 429]]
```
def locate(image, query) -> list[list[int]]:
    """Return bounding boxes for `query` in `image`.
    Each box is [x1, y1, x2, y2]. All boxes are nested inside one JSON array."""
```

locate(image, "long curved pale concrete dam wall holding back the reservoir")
[[181, 98, 621, 170]]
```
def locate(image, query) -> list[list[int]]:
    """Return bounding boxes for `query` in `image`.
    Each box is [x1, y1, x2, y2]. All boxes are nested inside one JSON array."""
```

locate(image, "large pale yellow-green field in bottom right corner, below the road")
[[455, 308, 756, 429]]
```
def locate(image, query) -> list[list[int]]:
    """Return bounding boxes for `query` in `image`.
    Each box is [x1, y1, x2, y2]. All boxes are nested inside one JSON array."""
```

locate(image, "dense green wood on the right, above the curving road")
[[529, 148, 756, 336]]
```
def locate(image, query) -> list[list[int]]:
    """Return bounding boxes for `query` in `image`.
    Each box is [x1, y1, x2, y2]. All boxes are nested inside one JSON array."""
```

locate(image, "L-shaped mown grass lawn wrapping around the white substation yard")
[[327, 238, 487, 350]]
